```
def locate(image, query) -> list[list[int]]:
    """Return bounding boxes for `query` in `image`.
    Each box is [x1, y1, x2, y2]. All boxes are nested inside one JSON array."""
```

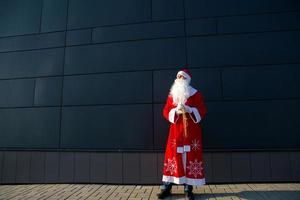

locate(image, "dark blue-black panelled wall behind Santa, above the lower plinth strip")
[[0, 0, 300, 152]]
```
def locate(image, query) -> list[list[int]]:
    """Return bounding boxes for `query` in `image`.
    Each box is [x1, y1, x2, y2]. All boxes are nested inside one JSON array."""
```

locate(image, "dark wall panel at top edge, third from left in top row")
[[68, 0, 151, 29]]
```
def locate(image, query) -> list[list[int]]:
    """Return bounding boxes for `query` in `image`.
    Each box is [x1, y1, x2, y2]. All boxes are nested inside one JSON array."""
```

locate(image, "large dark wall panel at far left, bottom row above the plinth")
[[0, 107, 60, 148]]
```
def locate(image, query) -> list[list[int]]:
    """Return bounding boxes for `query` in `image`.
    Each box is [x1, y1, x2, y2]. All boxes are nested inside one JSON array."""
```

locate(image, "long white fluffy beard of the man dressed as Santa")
[[170, 79, 190, 105]]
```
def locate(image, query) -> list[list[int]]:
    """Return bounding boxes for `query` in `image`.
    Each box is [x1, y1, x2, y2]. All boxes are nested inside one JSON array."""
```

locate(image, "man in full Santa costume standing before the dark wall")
[[158, 69, 206, 199]]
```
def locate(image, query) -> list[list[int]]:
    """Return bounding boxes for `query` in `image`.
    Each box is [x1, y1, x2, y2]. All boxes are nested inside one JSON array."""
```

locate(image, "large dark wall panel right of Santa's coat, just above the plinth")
[[203, 100, 300, 149]]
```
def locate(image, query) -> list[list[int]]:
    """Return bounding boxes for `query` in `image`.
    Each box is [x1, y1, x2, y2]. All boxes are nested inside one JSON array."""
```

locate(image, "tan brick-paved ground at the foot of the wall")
[[0, 183, 300, 200]]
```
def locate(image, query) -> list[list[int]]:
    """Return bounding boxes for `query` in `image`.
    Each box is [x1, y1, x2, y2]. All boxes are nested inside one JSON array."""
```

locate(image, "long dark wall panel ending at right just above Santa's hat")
[[65, 38, 185, 74]]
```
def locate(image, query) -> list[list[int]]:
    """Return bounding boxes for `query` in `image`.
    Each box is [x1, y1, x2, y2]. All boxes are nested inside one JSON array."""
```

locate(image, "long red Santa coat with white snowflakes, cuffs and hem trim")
[[162, 88, 207, 185]]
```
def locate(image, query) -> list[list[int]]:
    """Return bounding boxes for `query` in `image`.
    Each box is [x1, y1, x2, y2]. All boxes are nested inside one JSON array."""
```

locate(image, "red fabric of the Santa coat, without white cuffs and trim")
[[163, 91, 207, 184]]
